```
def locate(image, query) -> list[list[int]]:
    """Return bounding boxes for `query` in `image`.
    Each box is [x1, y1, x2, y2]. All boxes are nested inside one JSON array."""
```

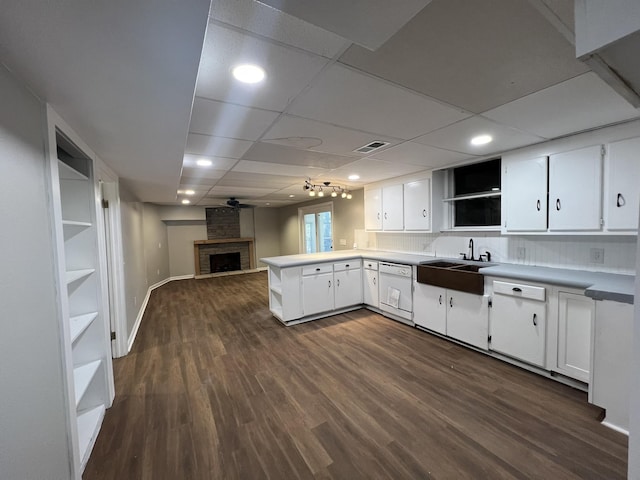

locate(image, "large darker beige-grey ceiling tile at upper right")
[[340, 0, 589, 113]]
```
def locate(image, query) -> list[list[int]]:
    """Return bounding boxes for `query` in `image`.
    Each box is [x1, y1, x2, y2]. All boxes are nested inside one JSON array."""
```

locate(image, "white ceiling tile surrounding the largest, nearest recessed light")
[[196, 22, 328, 112]]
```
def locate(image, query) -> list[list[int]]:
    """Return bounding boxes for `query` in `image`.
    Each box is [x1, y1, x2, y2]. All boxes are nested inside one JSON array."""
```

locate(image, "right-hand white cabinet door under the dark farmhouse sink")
[[446, 290, 489, 350]]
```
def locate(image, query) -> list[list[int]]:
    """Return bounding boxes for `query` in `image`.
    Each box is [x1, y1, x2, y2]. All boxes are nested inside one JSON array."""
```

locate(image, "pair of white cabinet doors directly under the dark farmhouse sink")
[[413, 282, 489, 350]]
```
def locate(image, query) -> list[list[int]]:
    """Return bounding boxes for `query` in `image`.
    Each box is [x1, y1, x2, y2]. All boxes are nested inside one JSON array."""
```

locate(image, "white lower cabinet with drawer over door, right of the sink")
[[489, 281, 547, 367]]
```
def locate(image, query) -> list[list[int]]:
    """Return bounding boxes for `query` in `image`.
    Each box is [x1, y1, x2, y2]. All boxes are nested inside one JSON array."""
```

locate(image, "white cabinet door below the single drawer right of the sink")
[[490, 295, 547, 367]]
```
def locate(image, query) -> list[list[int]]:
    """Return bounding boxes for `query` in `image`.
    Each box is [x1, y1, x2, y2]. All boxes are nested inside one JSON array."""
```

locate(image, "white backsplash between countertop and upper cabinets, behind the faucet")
[[355, 230, 637, 274]]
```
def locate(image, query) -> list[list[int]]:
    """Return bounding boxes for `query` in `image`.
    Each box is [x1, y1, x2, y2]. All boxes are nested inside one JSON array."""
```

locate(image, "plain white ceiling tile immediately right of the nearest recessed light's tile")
[[289, 64, 469, 140]]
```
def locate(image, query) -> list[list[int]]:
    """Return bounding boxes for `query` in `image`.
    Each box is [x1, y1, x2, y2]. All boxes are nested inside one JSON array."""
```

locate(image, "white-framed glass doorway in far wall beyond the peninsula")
[[298, 202, 333, 253]]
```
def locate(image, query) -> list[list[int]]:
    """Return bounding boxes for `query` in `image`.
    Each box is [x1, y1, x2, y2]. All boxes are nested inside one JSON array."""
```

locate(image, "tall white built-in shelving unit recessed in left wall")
[[49, 113, 114, 479]]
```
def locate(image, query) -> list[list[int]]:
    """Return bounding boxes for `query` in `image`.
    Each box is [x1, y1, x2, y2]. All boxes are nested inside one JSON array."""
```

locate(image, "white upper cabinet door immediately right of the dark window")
[[502, 157, 547, 232]]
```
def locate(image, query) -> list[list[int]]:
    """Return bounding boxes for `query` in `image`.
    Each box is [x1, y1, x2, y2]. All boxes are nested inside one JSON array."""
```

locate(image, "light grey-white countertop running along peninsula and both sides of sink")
[[260, 250, 635, 304]]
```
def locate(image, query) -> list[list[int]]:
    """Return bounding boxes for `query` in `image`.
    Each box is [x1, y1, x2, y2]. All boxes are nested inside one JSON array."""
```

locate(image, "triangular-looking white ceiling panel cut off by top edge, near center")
[[260, 0, 431, 50]]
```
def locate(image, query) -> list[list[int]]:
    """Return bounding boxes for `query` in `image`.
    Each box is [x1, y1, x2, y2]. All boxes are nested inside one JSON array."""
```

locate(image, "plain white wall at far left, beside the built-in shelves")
[[0, 65, 71, 479]]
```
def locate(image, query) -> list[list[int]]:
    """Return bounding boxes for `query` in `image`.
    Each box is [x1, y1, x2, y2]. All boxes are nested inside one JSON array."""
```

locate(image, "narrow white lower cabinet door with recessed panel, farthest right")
[[557, 292, 595, 382]]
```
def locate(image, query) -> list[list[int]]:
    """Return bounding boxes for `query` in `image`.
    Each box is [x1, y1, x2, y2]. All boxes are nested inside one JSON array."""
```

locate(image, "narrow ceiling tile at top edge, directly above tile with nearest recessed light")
[[211, 0, 351, 58]]
